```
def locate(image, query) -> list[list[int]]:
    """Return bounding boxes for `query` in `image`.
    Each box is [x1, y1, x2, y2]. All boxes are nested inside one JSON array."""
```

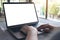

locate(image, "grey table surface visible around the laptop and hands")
[[0, 19, 60, 40]]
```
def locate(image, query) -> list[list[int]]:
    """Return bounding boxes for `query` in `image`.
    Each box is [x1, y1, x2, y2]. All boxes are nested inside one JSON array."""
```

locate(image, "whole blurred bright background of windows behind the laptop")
[[0, 0, 60, 22]]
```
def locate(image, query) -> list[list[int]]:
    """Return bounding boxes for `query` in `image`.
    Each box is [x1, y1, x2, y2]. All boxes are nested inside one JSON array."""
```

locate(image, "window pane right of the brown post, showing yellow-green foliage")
[[48, 0, 60, 22]]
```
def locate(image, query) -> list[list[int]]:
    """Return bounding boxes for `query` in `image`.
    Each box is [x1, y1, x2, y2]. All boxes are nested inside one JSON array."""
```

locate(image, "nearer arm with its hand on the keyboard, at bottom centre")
[[22, 26, 38, 40]]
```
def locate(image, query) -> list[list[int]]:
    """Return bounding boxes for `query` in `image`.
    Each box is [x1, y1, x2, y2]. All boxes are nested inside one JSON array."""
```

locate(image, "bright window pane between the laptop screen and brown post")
[[32, 0, 46, 18]]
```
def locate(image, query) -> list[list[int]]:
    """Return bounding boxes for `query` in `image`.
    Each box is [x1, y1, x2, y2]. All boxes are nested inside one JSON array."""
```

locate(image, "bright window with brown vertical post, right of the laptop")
[[32, 0, 60, 22]]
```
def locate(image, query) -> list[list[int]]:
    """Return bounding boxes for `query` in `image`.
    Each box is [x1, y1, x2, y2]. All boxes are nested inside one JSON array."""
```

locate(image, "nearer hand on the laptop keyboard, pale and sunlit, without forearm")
[[21, 25, 37, 34]]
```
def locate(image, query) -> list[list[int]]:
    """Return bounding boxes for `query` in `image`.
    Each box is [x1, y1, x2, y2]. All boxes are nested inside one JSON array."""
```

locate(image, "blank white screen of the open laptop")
[[4, 4, 37, 26]]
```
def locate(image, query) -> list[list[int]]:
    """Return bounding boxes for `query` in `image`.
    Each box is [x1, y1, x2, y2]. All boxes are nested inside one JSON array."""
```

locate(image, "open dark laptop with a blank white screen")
[[3, 2, 38, 39]]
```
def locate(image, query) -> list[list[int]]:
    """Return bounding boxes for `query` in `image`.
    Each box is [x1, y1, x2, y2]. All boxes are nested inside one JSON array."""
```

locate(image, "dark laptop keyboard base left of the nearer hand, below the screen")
[[7, 28, 25, 40]]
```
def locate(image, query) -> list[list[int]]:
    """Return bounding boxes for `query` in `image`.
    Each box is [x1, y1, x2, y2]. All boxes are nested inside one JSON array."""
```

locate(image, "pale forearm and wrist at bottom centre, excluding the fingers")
[[26, 26, 38, 40]]
